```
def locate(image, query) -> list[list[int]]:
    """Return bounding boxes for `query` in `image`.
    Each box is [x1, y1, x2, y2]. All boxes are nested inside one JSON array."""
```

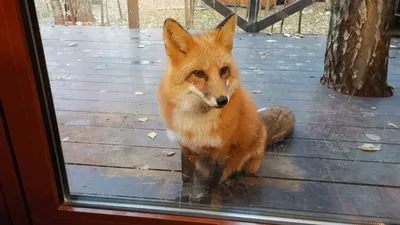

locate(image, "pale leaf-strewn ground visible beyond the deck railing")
[[35, 0, 330, 34]]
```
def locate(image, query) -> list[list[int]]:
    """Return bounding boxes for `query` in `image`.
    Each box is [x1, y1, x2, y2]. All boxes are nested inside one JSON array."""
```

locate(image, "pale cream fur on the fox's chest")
[[168, 108, 222, 151]]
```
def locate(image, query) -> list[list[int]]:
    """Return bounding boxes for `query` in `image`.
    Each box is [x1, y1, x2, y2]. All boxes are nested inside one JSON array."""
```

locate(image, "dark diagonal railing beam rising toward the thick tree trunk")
[[257, 0, 319, 32]]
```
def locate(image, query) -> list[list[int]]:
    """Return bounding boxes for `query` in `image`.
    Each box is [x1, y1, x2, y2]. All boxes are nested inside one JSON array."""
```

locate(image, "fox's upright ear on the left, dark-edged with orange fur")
[[163, 18, 192, 56]]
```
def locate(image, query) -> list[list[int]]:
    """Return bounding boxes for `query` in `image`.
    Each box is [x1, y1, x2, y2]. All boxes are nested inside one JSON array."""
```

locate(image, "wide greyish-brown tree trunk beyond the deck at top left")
[[68, 0, 94, 24]]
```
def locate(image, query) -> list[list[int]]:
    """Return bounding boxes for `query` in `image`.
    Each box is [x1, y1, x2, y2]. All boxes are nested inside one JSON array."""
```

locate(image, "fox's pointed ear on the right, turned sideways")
[[216, 14, 236, 51]]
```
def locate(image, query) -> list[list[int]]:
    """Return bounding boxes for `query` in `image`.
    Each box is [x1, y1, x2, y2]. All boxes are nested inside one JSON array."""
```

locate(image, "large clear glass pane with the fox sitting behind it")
[[29, 0, 400, 222]]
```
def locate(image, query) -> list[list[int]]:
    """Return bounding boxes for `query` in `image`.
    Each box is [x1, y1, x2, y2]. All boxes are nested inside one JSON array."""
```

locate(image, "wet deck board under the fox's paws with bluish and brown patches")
[[67, 165, 400, 219]]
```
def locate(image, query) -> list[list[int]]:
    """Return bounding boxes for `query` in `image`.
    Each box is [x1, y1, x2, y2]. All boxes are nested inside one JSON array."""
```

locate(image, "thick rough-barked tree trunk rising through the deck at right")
[[321, 0, 395, 97]]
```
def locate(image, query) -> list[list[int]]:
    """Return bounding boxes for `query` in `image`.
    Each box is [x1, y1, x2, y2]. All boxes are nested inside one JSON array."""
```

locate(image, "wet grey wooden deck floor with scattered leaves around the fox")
[[41, 27, 400, 222]]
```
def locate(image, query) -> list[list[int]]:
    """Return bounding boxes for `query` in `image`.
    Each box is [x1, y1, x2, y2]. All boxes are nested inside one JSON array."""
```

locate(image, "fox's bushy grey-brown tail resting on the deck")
[[258, 106, 295, 146]]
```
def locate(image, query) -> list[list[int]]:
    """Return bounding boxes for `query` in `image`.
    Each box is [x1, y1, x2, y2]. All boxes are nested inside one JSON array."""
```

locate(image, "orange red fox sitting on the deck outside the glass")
[[158, 14, 294, 186]]
